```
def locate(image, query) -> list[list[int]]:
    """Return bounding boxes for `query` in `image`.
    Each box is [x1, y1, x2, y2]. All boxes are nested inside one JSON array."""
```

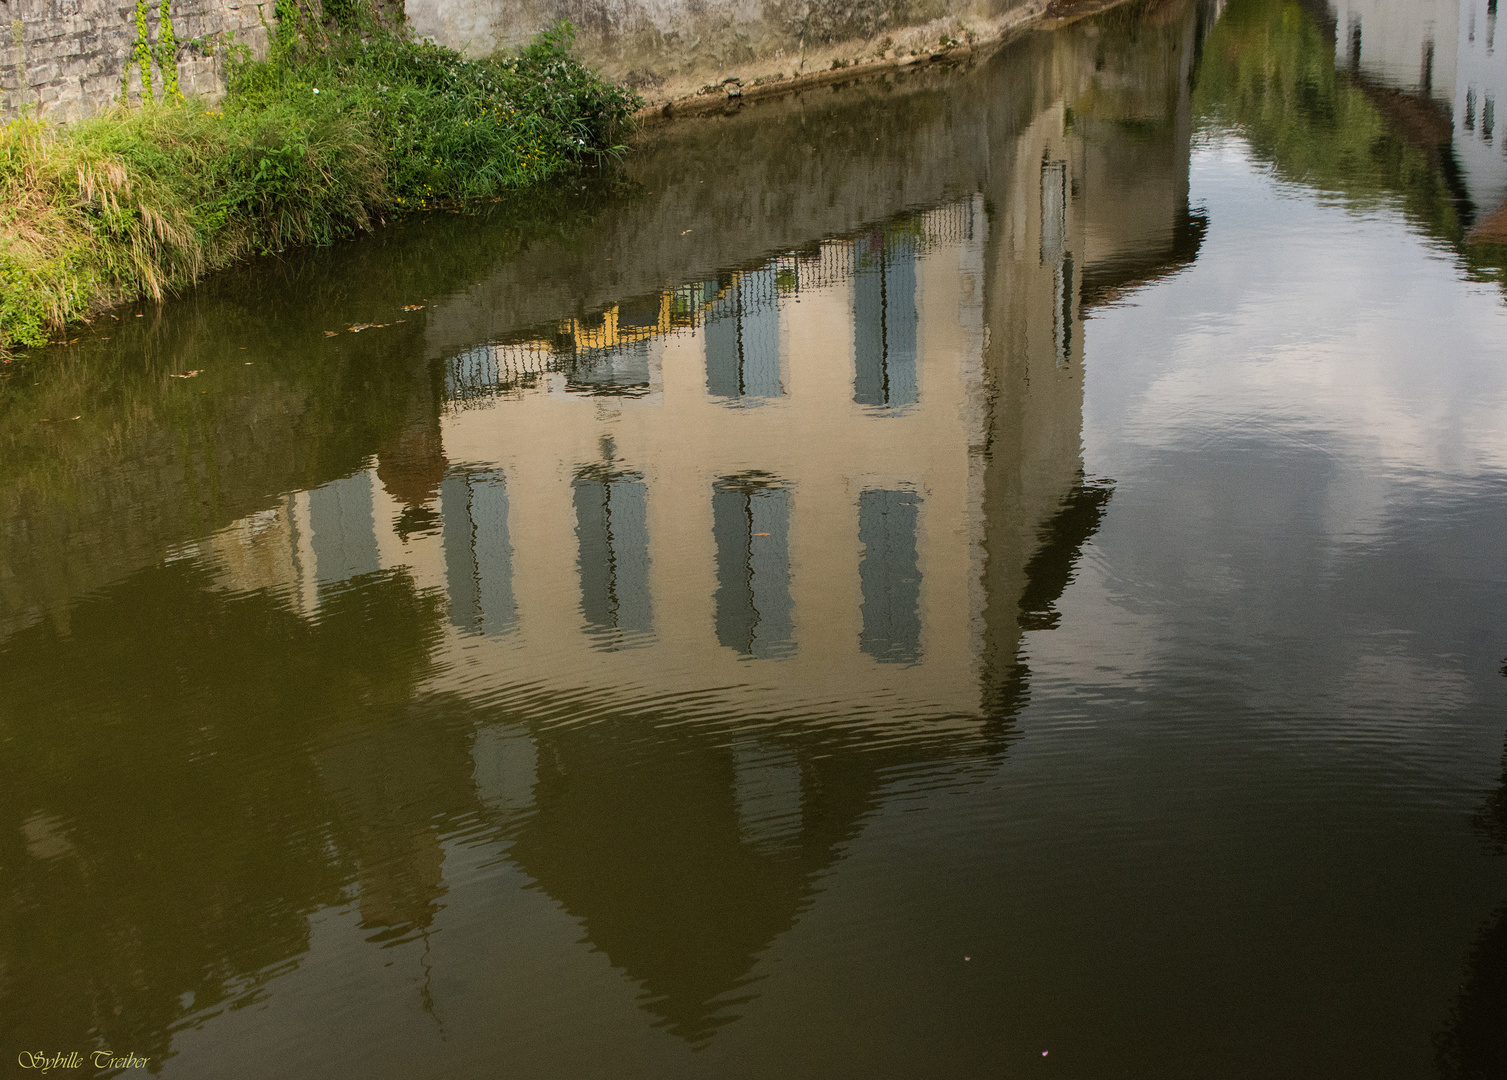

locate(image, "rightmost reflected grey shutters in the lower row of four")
[[857, 491, 921, 664]]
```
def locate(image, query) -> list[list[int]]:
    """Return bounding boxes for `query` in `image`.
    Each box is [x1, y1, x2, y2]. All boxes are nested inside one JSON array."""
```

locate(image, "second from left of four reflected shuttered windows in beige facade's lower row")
[[571, 467, 651, 649]]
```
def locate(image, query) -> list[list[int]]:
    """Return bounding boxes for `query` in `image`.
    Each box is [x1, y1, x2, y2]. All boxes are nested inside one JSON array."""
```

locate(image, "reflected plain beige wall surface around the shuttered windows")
[[431, 199, 987, 729]]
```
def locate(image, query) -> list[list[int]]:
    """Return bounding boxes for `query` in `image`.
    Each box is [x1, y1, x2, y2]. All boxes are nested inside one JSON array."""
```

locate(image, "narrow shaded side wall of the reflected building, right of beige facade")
[[981, 3, 1218, 738]]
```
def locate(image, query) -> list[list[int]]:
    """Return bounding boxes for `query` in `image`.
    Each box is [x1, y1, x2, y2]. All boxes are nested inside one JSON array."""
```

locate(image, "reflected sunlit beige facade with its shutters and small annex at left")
[[226, 199, 988, 718]]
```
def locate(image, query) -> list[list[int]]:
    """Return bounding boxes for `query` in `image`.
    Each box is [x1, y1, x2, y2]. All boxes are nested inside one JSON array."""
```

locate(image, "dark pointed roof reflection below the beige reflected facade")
[[509, 706, 910, 1042]]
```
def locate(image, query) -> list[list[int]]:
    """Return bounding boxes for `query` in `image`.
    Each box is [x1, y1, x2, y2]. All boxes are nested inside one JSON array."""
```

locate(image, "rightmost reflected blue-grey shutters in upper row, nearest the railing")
[[853, 232, 918, 408]]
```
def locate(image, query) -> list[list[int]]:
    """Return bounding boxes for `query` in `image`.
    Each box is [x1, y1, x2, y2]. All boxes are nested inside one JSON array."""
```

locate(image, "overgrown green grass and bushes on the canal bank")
[[0, 16, 639, 354]]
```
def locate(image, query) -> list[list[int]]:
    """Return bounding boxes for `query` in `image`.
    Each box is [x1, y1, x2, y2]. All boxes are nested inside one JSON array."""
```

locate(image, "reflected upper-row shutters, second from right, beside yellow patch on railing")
[[704, 268, 784, 401]]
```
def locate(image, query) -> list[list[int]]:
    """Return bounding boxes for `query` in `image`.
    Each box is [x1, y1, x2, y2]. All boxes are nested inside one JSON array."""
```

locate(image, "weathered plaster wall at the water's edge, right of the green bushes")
[[405, 0, 1043, 89]]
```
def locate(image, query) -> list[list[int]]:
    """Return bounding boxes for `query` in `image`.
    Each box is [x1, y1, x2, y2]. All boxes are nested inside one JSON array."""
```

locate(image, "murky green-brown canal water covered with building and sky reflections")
[[0, 0, 1507, 1080]]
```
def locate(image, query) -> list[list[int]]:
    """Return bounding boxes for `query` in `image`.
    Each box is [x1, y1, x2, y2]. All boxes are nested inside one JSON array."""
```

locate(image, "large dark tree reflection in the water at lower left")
[[0, 563, 452, 1060]]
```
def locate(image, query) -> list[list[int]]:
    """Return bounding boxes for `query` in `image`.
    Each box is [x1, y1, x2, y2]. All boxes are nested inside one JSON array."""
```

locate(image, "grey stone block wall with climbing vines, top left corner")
[[0, 0, 273, 121]]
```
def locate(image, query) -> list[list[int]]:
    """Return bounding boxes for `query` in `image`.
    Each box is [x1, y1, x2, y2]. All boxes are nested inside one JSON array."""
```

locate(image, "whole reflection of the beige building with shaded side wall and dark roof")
[[61, 0, 1223, 1041]]
